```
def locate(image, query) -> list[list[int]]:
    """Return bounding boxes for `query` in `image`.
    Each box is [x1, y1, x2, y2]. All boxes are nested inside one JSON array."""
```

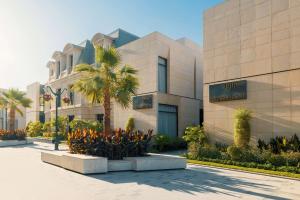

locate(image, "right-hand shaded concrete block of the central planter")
[[124, 154, 186, 171]]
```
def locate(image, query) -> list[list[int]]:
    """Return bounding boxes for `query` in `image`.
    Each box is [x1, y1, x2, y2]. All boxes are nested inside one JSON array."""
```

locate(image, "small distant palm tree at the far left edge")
[[0, 89, 32, 131]]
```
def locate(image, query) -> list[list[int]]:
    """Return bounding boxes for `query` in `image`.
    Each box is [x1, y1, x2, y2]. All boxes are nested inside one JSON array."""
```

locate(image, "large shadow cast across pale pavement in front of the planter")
[[89, 167, 288, 200]]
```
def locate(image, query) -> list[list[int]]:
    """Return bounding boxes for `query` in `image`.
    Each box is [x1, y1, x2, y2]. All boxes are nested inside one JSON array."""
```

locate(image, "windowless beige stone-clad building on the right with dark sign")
[[203, 0, 300, 143]]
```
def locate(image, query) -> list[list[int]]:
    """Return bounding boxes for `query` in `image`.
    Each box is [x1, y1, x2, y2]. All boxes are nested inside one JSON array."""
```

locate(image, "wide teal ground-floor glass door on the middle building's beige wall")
[[158, 104, 178, 137]]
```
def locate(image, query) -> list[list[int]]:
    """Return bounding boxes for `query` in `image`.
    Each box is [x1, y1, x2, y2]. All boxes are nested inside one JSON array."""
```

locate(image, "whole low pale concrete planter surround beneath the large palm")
[[41, 151, 186, 174]]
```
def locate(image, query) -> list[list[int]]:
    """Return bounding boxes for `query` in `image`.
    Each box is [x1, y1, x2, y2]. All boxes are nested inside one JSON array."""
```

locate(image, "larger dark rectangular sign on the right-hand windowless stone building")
[[209, 80, 247, 103]]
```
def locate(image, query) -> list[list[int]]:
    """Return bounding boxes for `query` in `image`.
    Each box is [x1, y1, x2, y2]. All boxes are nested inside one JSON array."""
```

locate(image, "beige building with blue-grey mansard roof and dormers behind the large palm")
[[29, 29, 203, 136]]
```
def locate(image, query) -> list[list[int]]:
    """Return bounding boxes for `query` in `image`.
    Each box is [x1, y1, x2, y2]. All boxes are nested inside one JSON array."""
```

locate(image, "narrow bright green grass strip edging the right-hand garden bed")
[[188, 160, 300, 180]]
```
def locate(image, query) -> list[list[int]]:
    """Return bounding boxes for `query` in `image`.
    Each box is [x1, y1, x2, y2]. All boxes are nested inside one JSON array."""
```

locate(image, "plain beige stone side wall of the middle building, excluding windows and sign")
[[113, 32, 202, 135]]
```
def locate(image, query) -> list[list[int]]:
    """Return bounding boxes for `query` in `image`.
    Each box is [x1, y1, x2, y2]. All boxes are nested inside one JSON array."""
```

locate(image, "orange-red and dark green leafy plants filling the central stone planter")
[[68, 129, 152, 160]]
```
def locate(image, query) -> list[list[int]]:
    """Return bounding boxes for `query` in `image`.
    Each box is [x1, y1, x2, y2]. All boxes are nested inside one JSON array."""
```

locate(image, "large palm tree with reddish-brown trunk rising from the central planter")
[[72, 46, 139, 135]]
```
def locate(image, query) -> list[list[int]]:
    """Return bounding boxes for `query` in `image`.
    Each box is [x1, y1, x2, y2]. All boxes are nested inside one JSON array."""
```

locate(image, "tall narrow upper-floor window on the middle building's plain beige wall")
[[158, 57, 168, 93]]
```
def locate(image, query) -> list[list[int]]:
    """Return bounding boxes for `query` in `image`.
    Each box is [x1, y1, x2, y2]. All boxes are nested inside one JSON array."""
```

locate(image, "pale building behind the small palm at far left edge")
[[0, 88, 26, 130]]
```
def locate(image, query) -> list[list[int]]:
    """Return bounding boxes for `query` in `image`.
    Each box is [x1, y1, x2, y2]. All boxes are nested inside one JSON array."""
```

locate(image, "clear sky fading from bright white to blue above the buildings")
[[0, 0, 223, 90]]
